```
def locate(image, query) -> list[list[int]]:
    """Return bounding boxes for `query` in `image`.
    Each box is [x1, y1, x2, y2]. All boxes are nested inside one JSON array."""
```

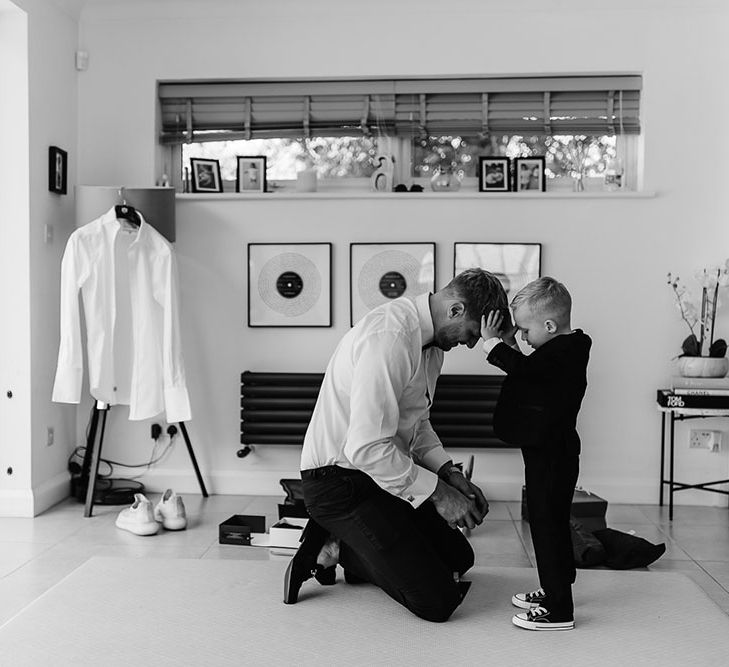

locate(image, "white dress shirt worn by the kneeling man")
[[301, 294, 451, 507]]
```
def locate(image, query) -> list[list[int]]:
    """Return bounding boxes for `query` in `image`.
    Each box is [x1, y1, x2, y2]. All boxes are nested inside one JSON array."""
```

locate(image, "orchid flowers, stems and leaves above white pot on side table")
[[667, 259, 729, 357]]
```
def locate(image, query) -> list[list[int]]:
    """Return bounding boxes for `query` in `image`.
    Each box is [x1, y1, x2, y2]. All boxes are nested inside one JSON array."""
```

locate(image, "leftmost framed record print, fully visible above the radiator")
[[248, 243, 332, 327]]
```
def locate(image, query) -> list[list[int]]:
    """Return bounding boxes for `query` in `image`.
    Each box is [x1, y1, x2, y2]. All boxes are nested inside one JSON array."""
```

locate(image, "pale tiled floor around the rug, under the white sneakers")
[[0, 494, 729, 625]]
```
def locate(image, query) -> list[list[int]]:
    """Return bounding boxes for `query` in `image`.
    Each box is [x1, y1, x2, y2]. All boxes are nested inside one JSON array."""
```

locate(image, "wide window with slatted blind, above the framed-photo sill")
[[158, 75, 642, 188]]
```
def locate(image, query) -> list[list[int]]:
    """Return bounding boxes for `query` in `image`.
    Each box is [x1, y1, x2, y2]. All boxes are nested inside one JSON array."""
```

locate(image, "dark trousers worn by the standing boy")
[[522, 447, 580, 621]]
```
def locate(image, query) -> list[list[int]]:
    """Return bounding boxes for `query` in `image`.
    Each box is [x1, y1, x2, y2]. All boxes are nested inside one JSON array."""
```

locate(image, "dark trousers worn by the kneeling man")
[[301, 466, 474, 622]]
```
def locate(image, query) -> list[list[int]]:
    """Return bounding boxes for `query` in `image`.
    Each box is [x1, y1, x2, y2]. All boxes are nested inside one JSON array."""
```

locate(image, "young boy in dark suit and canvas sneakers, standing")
[[481, 277, 592, 630]]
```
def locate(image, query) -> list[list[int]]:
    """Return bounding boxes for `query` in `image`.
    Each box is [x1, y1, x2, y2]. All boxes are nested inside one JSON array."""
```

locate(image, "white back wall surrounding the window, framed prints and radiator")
[[65, 0, 729, 503]]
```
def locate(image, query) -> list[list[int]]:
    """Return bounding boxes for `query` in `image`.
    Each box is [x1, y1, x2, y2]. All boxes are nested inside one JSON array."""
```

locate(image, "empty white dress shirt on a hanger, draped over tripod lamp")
[[53, 208, 190, 422]]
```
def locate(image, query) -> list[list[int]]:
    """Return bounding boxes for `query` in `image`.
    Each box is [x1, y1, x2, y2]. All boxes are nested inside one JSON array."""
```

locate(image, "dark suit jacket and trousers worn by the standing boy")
[[488, 329, 592, 620]]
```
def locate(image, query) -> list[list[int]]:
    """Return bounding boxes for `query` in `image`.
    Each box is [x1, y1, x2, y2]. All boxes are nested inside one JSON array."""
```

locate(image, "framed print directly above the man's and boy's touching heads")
[[453, 243, 542, 300]]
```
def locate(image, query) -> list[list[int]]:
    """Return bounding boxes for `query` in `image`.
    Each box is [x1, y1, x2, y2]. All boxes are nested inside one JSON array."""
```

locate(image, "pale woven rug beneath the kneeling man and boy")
[[0, 558, 729, 667]]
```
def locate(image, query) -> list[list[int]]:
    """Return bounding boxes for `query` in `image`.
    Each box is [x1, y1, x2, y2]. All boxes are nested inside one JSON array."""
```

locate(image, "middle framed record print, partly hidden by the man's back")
[[349, 243, 435, 326]]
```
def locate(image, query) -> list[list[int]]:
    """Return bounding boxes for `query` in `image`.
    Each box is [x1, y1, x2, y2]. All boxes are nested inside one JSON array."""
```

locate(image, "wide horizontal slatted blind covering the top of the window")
[[159, 76, 642, 143]]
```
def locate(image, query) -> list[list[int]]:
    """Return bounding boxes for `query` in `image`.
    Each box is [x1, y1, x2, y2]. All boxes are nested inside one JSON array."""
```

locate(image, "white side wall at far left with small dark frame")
[[0, 0, 78, 516]]
